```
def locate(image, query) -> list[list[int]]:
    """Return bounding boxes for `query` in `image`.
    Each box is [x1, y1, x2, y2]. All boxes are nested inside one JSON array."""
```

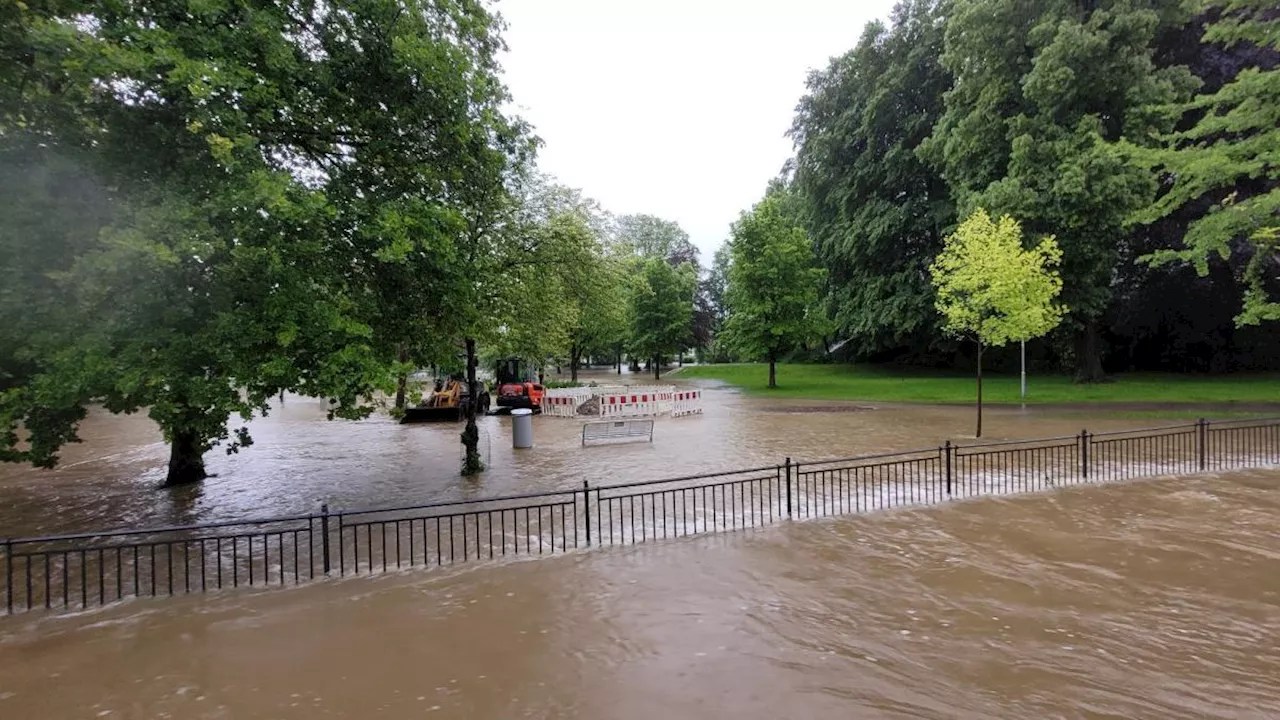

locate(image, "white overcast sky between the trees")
[[497, 0, 893, 266]]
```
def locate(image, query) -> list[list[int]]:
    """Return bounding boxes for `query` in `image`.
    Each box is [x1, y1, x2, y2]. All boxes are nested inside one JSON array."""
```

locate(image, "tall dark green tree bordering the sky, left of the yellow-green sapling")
[[791, 0, 955, 355]]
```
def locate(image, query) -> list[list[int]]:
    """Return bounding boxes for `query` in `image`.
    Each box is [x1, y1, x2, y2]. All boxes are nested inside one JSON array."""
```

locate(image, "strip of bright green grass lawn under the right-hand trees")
[[680, 364, 1280, 404]]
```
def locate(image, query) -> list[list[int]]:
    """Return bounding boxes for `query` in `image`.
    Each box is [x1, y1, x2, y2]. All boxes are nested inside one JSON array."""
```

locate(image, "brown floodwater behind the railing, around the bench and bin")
[[0, 372, 1239, 537]]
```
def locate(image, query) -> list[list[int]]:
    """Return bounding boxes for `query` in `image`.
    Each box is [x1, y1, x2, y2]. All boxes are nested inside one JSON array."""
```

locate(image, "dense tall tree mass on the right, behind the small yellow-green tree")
[[768, 0, 1280, 380]]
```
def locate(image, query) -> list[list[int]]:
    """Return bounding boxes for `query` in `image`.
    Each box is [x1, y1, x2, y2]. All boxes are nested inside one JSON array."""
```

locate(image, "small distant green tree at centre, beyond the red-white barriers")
[[628, 258, 695, 380]]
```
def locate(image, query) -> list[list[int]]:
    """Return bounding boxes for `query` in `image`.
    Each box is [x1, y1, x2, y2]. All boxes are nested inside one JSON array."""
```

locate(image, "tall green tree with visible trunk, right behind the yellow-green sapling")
[[920, 0, 1196, 382]]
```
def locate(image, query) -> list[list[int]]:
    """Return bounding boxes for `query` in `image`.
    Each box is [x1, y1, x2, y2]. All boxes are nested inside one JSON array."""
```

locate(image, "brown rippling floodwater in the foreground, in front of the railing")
[[0, 471, 1280, 720]]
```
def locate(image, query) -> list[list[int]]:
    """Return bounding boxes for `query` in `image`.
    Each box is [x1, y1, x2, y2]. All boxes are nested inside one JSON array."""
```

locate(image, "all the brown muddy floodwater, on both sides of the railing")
[[0, 368, 1280, 720]]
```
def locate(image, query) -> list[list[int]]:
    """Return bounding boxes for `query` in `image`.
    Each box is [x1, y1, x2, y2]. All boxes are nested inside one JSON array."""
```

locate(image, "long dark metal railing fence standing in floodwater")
[[0, 419, 1280, 615]]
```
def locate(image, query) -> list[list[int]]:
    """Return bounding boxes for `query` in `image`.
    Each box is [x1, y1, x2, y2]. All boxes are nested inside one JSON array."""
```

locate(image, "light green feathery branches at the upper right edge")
[[1135, 0, 1280, 325]]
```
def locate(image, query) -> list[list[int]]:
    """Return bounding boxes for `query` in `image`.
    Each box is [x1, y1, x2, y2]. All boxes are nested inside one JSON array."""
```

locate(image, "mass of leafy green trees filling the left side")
[[0, 0, 705, 484]]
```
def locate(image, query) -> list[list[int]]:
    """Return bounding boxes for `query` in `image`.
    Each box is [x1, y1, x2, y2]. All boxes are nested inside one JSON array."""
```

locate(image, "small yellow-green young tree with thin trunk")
[[929, 209, 1066, 437]]
